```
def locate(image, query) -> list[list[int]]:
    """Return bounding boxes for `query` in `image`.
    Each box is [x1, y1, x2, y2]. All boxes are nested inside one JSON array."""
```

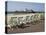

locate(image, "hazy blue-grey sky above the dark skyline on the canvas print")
[[7, 1, 45, 11]]
